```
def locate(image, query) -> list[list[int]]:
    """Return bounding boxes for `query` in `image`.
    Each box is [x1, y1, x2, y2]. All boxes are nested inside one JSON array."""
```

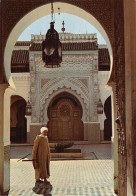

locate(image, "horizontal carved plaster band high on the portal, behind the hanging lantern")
[[35, 54, 94, 75]]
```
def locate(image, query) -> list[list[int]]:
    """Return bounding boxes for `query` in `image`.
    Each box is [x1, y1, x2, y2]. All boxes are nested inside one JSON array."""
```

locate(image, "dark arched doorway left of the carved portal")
[[10, 96, 27, 143]]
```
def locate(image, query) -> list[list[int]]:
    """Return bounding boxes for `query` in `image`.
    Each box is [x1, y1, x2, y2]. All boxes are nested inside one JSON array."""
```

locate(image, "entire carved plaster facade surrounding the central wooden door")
[[30, 48, 99, 122]]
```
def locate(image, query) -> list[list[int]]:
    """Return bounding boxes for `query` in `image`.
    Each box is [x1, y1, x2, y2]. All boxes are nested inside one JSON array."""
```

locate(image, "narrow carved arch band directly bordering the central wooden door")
[[40, 86, 89, 124]]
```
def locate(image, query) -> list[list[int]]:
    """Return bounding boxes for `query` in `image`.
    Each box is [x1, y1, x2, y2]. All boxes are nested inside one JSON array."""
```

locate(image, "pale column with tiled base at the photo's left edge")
[[0, 84, 10, 195]]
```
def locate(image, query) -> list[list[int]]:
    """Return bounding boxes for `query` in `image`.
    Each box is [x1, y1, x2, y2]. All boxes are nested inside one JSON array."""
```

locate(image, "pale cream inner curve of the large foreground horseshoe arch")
[[4, 2, 113, 86]]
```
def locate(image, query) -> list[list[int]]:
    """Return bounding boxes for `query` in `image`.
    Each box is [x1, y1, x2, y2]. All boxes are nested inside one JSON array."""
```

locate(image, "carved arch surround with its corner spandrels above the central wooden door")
[[40, 78, 89, 122]]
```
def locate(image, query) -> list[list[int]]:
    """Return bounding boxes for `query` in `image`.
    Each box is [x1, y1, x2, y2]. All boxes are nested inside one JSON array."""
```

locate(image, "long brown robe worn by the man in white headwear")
[[32, 135, 50, 179]]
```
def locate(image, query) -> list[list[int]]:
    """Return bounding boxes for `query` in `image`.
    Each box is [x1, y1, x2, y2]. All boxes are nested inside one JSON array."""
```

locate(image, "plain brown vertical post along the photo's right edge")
[[124, 0, 136, 196]]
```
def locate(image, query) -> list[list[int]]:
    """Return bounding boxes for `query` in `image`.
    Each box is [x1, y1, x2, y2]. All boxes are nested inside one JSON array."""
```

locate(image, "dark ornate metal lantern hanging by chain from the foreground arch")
[[42, 0, 62, 68]]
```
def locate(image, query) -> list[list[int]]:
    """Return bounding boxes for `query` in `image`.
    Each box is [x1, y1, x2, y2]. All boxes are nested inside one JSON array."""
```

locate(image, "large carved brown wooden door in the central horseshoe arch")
[[47, 92, 83, 141]]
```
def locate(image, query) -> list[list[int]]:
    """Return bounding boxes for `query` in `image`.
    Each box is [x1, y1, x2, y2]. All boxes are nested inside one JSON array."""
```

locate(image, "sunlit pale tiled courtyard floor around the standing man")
[[9, 144, 115, 196]]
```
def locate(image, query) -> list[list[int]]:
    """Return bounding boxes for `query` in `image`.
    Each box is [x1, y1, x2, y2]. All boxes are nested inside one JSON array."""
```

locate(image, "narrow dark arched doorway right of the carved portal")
[[104, 96, 112, 140]]
